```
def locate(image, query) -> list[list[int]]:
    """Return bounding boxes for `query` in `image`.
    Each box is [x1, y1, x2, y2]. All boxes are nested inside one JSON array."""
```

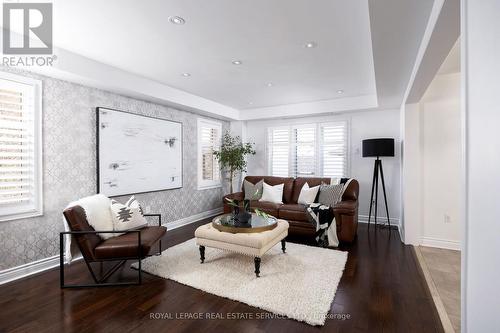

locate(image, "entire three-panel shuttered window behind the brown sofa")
[[267, 121, 348, 177]]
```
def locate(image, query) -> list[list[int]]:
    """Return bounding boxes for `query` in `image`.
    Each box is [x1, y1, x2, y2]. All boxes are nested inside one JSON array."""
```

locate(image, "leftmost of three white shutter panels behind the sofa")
[[267, 128, 290, 177]]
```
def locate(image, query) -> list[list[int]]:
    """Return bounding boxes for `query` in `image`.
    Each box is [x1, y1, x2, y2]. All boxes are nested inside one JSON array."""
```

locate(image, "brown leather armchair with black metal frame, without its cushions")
[[59, 206, 167, 288]]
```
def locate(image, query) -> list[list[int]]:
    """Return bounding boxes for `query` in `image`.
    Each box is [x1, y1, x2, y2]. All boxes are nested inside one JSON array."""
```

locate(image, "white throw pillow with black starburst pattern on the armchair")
[[111, 196, 148, 231]]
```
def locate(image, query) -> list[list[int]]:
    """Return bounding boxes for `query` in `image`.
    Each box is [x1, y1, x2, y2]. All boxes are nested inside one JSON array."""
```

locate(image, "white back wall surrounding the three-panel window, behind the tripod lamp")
[[246, 110, 400, 223]]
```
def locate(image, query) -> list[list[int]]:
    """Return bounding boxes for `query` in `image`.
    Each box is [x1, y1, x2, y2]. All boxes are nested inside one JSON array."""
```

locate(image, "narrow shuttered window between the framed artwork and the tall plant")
[[198, 118, 222, 189]]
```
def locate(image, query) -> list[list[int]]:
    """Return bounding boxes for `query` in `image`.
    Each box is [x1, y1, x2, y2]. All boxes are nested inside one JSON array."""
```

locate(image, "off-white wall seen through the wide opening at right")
[[403, 73, 462, 250]]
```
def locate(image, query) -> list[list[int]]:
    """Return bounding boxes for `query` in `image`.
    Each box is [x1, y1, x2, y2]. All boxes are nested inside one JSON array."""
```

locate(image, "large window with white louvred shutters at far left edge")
[[0, 73, 43, 221]]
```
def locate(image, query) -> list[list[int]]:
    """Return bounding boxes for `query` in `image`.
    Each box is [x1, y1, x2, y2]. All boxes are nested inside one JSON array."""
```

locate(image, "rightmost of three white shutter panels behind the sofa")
[[319, 121, 347, 178]]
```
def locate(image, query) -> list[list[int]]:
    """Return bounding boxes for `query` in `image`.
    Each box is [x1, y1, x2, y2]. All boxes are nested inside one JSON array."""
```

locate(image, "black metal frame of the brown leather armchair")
[[59, 214, 162, 289]]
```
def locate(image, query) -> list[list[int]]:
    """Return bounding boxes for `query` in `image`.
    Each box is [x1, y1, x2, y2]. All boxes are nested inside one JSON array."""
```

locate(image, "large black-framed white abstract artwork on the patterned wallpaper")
[[96, 107, 182, 197]]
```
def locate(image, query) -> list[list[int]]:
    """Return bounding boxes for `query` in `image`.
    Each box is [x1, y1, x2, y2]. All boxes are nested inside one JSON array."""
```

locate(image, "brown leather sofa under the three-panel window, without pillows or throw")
[[223, 176, 359, 242]]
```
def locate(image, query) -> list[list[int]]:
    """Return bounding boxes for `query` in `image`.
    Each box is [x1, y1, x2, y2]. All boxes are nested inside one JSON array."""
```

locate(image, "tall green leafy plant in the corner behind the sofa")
[[214, 132, 255, 193]]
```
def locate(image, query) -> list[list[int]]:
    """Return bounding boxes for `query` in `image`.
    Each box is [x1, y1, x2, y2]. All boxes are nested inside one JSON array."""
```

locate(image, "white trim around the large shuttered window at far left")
[[0, 71, 44, 222]]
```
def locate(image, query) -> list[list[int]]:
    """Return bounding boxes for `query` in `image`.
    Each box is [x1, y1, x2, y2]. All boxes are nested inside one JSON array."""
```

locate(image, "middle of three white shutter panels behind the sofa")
[[290, 125, 317, 177]]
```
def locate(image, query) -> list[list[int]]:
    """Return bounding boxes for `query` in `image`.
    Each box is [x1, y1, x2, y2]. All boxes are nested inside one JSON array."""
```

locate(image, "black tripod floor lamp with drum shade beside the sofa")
[[363, 138, 394, 227]]
